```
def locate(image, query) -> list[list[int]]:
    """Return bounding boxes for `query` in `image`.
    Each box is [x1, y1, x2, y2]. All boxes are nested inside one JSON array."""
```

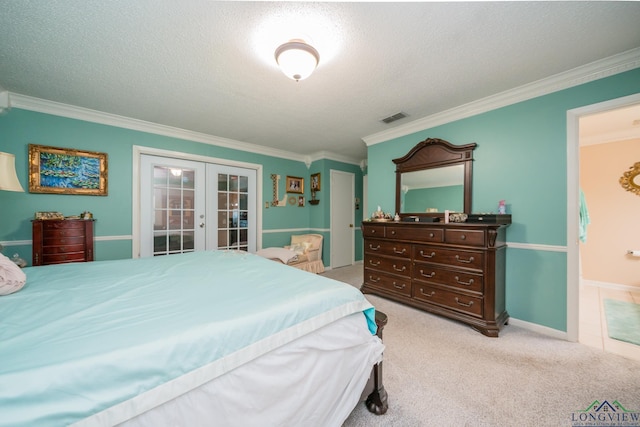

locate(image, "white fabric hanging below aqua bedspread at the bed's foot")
[[121, 313, 384, 427]]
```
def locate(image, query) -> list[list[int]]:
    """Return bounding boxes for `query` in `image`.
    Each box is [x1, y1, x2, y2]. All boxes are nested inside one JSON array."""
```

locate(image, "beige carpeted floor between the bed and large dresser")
[[325, 264, 640, 427]]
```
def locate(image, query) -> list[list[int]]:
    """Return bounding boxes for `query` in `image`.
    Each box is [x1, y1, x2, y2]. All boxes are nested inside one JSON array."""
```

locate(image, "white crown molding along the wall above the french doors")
[[11, 93, 308, 162]]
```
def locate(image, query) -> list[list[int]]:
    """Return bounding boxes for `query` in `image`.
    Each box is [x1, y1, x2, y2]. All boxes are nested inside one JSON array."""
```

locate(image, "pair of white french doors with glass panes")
[[140, 155, 257, 257]]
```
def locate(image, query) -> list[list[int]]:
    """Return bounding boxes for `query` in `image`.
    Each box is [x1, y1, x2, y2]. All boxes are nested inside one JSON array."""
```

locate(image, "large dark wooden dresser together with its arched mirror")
[[361, 138, 510, 337]]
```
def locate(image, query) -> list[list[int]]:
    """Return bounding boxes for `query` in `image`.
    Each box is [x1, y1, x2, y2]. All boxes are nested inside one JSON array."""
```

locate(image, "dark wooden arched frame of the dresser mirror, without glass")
[[393, 138, 478, 218]]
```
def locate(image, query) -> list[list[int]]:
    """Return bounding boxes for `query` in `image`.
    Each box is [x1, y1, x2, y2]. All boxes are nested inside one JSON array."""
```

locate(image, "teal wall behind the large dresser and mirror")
[[368, 69, 640, 331]]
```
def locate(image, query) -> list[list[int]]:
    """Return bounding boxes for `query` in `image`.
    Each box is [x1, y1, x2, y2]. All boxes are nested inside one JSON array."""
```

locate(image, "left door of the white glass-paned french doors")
[[140, 155, 206, 257]]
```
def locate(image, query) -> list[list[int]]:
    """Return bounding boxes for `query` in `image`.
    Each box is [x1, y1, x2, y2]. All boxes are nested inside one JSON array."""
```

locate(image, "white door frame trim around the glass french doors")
[[131, 145, 263, 258]]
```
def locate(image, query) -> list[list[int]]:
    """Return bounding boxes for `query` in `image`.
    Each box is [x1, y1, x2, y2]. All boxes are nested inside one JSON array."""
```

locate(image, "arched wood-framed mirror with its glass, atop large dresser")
[[393, 138, 477, 218]]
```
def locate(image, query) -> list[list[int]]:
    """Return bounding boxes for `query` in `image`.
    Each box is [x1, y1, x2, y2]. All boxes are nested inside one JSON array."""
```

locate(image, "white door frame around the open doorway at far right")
[[567, 94, 640, 342]]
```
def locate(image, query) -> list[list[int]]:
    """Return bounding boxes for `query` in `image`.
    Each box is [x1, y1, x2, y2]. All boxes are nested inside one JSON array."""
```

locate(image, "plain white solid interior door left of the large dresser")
[[330, 170, 355, 268]]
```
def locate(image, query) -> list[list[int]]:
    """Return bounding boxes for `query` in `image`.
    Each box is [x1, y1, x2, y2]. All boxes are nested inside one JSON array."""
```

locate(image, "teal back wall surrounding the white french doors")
[[0, 108, 362, 265]]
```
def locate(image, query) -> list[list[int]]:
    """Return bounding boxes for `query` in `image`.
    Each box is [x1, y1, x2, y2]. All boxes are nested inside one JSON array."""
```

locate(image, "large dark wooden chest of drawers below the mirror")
[[361, 222, 509, 337]]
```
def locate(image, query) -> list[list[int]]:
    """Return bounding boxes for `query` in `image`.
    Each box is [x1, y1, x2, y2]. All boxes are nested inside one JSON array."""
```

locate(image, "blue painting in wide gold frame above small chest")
[[29, 144, 108, 196]]
